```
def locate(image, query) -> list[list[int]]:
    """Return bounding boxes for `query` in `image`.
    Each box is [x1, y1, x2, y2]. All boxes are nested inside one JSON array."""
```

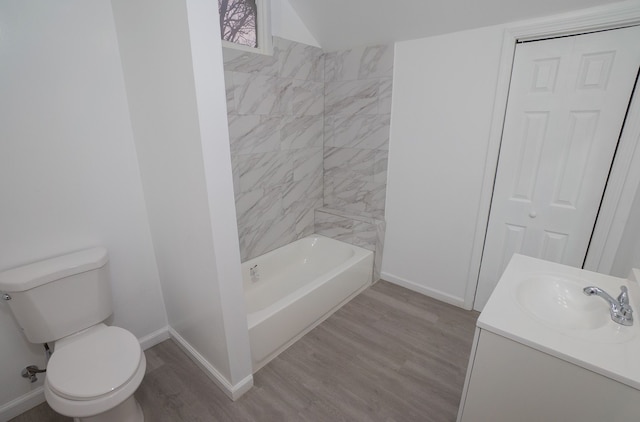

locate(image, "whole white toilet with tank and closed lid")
[[0, 248, 147, 422]]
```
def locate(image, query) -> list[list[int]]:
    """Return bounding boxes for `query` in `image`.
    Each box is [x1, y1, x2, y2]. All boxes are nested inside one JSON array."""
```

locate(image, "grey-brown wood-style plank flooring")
[[12, 281, 478, 422]]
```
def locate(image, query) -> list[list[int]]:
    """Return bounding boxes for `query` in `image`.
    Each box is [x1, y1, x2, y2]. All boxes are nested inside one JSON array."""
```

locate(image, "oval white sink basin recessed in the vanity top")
[[516, 274, 615, 330]]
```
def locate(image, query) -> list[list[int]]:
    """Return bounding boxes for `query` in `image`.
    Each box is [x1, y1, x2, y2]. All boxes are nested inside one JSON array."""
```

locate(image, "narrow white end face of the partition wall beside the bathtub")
[[187, 0, 253, 390]]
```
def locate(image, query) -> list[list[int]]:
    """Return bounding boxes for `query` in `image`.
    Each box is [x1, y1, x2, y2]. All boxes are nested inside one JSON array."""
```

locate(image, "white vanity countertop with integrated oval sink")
[[478, 254, 640, 390]]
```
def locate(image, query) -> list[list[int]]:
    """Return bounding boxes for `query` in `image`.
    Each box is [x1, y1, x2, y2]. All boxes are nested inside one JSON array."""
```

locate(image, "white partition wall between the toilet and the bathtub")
[[112, 0, 251, 396]]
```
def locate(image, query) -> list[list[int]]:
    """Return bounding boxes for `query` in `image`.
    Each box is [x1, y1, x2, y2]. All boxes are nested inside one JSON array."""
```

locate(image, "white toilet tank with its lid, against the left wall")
[[0, 247, 112, 343]]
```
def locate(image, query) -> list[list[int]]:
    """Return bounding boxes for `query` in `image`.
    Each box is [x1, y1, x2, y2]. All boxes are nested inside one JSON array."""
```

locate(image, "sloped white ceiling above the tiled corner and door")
[[289, 0, 616, 51]]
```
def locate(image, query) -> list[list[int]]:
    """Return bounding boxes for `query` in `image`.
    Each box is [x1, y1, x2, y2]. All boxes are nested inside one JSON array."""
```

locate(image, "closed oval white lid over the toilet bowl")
[[47, 326, 142, 400]]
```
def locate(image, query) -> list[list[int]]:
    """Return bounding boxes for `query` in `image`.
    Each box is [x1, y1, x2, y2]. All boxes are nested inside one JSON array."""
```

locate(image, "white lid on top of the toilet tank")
[[0, 247, 109, 293]]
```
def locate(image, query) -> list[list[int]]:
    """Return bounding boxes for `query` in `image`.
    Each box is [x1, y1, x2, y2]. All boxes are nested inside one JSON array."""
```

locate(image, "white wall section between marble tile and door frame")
[[382, 26, 502, 306]]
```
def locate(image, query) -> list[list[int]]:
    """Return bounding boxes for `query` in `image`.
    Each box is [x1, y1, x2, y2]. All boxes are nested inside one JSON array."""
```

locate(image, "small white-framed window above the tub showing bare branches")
[[218, 0, 271, 53]]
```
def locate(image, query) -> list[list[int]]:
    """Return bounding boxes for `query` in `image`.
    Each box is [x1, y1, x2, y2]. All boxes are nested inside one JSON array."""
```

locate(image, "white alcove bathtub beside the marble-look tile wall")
[[242, 235, 373, 372]]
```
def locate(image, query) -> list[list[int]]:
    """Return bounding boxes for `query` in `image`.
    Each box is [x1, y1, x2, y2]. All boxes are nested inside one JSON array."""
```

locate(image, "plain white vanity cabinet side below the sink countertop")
[[458, 328, 640, 422]]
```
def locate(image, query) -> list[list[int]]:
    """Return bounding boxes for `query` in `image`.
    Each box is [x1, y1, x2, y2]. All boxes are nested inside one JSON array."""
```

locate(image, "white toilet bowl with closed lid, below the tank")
[[44, 324, 146, 422]]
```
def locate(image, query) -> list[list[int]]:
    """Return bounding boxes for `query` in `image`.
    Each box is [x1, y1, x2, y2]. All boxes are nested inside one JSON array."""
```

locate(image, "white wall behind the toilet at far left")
[[0, 0, 167, 420]]
